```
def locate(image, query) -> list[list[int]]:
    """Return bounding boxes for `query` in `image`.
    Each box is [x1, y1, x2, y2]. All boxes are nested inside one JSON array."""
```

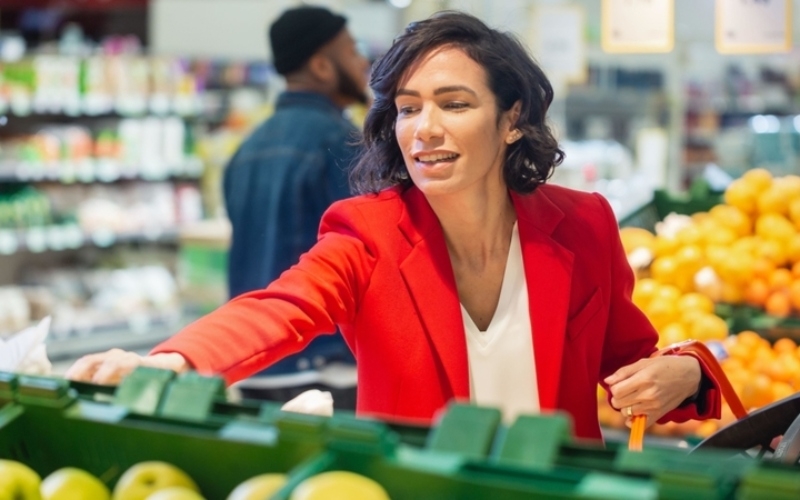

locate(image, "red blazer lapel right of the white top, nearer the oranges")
[[511, 189, 574, 410]]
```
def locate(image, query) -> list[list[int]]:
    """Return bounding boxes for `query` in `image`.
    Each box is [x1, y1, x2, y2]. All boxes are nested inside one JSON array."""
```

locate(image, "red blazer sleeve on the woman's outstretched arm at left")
[[151, 203, 375, 384]]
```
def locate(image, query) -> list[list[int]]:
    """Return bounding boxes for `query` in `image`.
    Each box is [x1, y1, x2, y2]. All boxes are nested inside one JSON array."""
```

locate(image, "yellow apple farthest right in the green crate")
[[289, 470, 389, 500]]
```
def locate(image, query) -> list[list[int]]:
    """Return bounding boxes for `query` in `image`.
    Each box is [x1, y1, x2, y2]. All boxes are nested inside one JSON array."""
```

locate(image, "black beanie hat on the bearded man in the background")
[[269, 6, 347, 75]]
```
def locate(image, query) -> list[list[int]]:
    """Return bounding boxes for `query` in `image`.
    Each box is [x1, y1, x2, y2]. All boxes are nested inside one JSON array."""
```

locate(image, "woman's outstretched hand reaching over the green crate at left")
[[64, 349, 189, 385]]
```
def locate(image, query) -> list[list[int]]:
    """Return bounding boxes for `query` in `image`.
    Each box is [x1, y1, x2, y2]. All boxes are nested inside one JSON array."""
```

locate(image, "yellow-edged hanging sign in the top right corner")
[[715, 0, 792, 54]]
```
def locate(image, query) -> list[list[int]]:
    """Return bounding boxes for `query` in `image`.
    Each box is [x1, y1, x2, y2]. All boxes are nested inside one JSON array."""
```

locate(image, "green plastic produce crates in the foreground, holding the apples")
[[0, 368, 800, 500]]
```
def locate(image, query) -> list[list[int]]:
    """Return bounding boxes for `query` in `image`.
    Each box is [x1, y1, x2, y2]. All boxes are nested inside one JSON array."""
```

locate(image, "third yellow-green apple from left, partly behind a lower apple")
[[112, 461, 200, 500]]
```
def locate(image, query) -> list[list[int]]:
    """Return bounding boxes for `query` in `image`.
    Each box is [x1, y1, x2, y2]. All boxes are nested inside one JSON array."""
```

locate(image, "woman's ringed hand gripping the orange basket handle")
[[605, 356, 703, 427]]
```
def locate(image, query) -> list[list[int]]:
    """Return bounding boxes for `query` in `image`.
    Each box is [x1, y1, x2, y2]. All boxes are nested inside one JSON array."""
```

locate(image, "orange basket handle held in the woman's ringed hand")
[[628, 340, 747, 451]]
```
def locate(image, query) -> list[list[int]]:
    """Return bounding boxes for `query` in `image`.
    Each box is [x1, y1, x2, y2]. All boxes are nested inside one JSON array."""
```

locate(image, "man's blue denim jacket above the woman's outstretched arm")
[[224, 92, 356, 297]]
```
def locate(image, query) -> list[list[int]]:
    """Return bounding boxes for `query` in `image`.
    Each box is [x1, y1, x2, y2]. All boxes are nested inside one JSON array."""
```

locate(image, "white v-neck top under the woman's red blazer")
[[461, 224, 539, 424]]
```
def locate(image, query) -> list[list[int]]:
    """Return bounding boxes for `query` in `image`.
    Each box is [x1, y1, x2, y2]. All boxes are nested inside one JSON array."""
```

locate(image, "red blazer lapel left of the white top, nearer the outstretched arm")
[[398, 187, 470, 399]]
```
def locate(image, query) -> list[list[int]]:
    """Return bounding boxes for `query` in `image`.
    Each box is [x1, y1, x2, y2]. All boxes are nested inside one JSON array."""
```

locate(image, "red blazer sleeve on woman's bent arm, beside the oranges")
[[595, 194, 721, 423]]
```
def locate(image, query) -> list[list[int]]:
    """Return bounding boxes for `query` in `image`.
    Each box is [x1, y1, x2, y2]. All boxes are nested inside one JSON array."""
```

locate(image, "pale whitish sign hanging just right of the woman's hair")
[[530, 5, 586, 83]]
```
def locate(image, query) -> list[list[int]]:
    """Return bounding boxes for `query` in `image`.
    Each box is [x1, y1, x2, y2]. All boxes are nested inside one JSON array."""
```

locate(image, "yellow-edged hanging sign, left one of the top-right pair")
[[601, 0, 675, 53]]
